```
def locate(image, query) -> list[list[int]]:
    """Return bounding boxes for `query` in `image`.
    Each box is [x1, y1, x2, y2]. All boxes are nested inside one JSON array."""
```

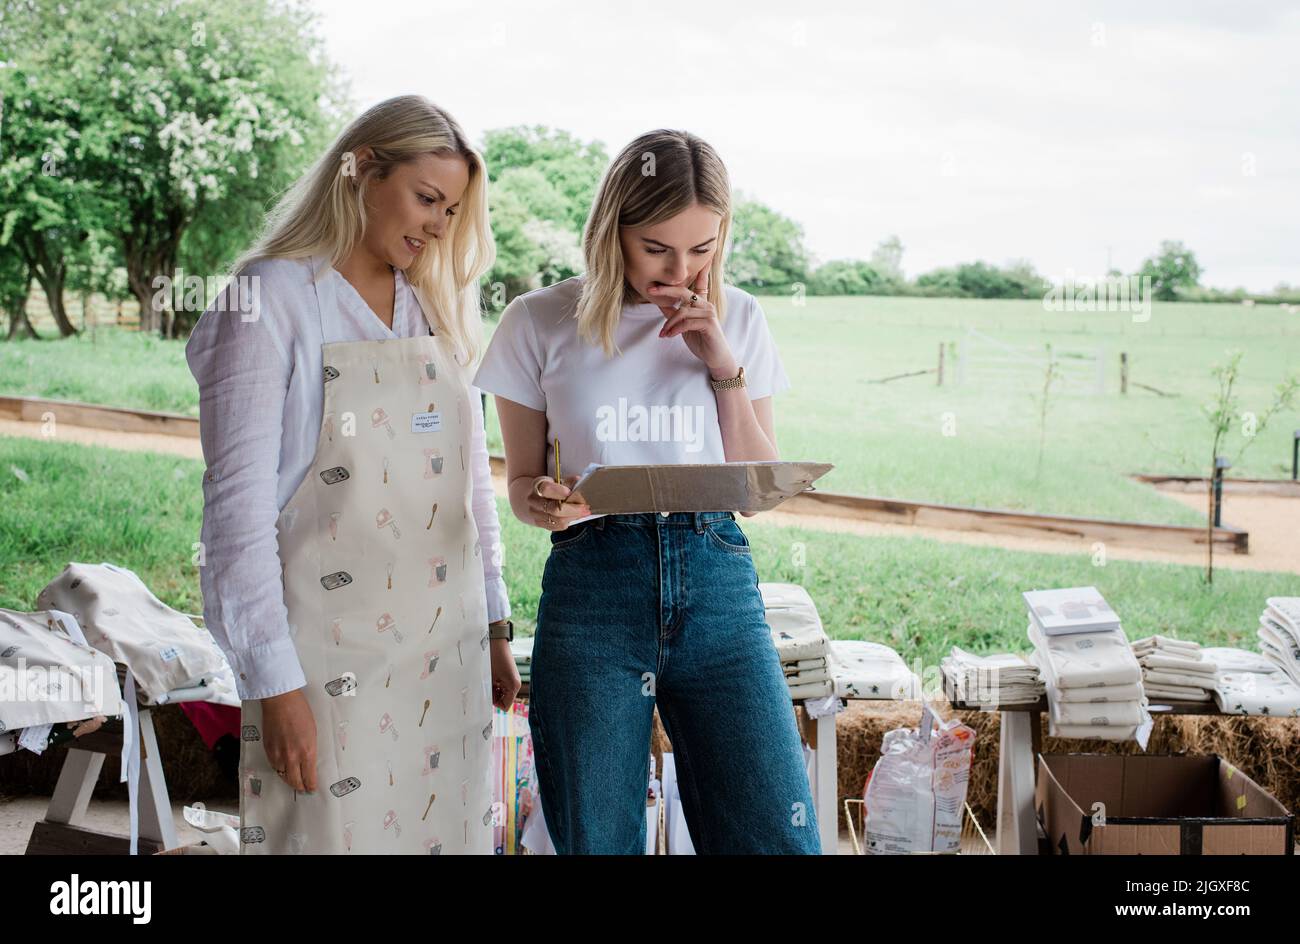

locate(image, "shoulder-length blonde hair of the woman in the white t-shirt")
[[576, 129, 732, 356]]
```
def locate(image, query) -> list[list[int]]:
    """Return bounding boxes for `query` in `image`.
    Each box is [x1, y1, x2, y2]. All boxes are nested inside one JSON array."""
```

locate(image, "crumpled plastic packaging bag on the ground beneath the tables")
[[863, 707, 975, 856]]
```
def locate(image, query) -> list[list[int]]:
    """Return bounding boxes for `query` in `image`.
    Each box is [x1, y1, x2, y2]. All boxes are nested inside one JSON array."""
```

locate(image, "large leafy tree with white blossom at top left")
[[4, 0, 337, 335]]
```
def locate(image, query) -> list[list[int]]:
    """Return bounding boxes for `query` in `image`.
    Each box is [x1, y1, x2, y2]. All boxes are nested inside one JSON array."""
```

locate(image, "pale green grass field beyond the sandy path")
[[0, 296, 1300, 524]]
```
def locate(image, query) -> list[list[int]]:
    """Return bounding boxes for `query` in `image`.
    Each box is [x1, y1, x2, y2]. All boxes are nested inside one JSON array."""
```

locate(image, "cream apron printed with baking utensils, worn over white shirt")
[[239, 267, 493, 854]]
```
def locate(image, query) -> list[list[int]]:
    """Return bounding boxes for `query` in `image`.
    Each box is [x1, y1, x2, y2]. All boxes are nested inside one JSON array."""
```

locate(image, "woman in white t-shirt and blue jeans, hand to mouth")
[[475, 130, 819, 854]]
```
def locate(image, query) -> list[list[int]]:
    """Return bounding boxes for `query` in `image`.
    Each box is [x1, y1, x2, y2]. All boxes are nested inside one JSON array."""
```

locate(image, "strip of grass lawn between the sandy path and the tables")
[[0, 437, 1300, 667]]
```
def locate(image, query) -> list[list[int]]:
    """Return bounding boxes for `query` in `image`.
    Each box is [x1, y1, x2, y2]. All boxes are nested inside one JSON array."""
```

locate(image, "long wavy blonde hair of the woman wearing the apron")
[[231, 95, 497, 365]]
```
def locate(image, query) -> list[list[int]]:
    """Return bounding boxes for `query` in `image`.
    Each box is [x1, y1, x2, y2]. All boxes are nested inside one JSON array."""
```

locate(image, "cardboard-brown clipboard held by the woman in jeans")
[[566, 460, 835, 515]]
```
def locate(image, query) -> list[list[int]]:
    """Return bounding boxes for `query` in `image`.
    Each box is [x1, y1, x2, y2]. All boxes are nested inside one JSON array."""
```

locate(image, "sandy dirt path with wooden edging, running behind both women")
[[0, 419, 1300, 573]]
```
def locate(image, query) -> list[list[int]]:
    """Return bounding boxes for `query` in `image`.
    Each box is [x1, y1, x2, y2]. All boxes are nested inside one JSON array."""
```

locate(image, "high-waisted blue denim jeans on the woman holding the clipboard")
[[529, 511, 820, 854]]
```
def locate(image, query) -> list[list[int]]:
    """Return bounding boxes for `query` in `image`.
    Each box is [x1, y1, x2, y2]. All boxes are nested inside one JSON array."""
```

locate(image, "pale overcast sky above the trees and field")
[[312, 0, 1300, 290]]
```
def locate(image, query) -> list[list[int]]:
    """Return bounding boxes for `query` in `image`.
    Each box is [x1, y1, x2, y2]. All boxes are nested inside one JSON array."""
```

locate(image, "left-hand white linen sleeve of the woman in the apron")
[[186, 276, 307, 700]]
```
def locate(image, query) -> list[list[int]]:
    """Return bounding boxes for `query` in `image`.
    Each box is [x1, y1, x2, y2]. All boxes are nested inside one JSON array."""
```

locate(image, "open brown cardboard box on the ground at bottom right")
[[1035, 754, 1295, 856]]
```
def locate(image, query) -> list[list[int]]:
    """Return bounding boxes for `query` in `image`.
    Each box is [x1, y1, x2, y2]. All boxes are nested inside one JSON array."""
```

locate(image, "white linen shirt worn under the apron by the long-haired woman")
[[185, 257, 510, 700]]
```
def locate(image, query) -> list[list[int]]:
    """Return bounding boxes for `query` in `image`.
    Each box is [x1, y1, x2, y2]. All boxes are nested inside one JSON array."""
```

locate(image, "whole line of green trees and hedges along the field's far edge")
[[0, 0, 1300, 337]]
